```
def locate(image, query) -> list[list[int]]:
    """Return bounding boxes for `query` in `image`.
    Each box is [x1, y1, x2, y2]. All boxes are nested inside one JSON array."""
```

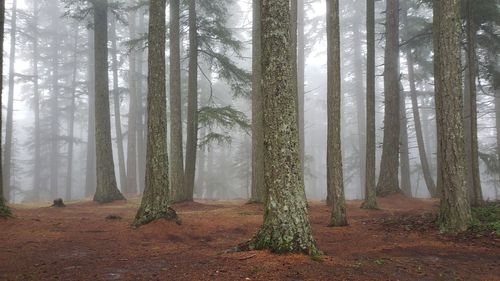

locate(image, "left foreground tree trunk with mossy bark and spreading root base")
[[134, 0, 176, 226]]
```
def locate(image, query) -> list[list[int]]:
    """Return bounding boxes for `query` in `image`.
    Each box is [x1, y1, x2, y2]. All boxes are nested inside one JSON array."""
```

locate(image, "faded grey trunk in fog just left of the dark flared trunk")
[[85, 29, 97, 196]]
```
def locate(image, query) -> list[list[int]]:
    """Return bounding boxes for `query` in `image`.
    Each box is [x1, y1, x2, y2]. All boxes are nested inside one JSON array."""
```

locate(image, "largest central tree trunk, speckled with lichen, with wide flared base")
[[239, 0, 319, 255]]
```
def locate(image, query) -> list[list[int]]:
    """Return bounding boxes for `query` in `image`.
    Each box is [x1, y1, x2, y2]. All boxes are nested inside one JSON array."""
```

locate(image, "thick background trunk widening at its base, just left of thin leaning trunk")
[[377, 0, 400, 196]]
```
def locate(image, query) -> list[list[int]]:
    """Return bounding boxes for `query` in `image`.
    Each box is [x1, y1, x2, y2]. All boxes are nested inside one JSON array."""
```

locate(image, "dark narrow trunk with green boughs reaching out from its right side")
[[184, 0, 198, 201]]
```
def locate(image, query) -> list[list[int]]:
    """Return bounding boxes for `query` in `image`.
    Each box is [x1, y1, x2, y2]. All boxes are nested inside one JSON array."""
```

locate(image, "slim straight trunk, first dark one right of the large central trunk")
[[326, 0, 347, 226]]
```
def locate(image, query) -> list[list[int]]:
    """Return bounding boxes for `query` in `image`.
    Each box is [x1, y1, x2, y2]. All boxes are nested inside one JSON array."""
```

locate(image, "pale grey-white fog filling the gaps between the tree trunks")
[[2, 0, 500, 203]]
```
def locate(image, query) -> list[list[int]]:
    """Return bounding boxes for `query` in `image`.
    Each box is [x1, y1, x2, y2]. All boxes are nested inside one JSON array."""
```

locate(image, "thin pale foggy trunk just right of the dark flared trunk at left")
[[110, 15, 127, 190]]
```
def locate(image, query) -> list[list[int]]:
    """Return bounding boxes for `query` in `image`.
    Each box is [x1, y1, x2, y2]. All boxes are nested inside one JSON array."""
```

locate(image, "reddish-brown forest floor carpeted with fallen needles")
[[0, 195, 500, 280]]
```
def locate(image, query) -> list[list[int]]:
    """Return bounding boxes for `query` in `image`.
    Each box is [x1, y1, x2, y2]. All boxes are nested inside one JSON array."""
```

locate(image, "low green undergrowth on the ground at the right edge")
[[470, 202, 500, 236]]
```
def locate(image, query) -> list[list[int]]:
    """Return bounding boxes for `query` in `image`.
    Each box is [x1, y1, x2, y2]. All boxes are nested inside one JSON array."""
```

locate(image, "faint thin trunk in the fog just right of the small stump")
[[66, 25, 78, 200]]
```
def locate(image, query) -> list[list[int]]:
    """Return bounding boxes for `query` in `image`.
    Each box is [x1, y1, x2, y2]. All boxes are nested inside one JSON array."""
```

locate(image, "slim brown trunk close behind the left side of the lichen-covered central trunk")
[[250, 0, 266, 202]]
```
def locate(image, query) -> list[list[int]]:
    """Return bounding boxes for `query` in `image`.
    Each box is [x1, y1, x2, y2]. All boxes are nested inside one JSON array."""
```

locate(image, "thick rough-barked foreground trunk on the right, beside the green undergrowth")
[[433, 0, 471, 233]]
